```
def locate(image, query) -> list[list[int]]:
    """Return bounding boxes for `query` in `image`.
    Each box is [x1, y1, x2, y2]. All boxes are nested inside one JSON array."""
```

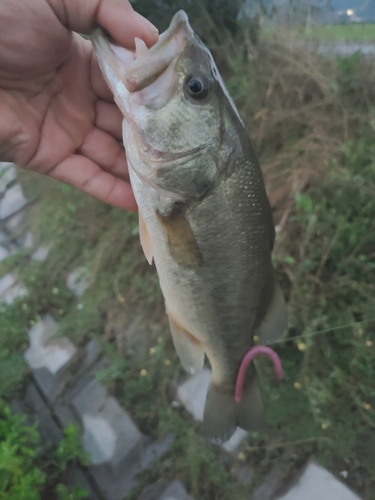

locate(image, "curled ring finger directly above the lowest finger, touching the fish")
[[78, 128, 129, 181]]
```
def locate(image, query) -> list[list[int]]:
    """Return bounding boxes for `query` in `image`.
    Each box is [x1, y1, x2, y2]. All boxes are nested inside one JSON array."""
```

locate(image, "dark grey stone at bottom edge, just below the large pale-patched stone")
[[90, 434, 173, 500]]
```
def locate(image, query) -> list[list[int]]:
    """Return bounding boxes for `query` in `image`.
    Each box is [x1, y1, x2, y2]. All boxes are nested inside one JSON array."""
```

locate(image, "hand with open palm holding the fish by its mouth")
[[0, 0, 158, 210]]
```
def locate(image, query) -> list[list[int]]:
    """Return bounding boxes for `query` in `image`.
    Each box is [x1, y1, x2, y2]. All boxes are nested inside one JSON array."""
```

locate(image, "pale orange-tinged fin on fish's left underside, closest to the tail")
[[168, 313, 204, 375]]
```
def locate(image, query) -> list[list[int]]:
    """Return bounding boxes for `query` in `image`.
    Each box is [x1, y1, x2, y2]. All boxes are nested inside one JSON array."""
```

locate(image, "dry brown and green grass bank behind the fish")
[[4, 23, 375, 500]]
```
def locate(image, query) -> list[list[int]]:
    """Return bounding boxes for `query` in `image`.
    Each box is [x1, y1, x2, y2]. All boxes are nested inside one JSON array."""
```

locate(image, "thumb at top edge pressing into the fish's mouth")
[[53, 0, 158, 48]]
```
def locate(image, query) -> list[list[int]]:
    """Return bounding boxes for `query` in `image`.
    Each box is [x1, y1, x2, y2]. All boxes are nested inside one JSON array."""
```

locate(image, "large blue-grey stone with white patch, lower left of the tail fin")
[[72, 380, 144, 473]]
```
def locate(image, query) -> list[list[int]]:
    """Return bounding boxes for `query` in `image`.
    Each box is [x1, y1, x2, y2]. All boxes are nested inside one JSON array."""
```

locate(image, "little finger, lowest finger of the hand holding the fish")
[[49, 155, 137, 212]]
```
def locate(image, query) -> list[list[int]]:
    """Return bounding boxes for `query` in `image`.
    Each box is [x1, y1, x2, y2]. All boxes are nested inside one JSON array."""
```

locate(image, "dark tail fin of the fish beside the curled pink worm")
[[201, 376, 265, 441]]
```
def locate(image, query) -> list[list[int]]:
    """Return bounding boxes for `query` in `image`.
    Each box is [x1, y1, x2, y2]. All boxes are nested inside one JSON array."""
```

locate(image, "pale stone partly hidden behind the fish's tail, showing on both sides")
[[177, 369, 247, 453]]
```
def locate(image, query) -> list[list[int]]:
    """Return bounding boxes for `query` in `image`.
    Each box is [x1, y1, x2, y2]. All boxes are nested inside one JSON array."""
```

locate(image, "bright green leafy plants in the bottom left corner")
[[0, 400, 87, 500]]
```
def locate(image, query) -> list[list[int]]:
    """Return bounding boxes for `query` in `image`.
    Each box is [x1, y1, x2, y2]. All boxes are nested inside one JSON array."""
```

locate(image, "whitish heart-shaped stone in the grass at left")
[[24, 315, 77, 374]]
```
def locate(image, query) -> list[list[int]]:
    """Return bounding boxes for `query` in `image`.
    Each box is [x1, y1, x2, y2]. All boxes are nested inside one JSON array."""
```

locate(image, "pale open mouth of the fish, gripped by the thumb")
[[91, 10, 194, 93]]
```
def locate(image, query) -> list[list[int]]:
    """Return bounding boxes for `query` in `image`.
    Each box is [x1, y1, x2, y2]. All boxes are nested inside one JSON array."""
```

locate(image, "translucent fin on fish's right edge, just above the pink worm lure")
[[255, 283, 288, 345]]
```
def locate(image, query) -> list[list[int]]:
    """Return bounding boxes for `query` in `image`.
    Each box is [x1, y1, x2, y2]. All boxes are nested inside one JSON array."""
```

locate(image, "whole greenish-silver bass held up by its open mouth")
[[91, 11, 287, 441]]
